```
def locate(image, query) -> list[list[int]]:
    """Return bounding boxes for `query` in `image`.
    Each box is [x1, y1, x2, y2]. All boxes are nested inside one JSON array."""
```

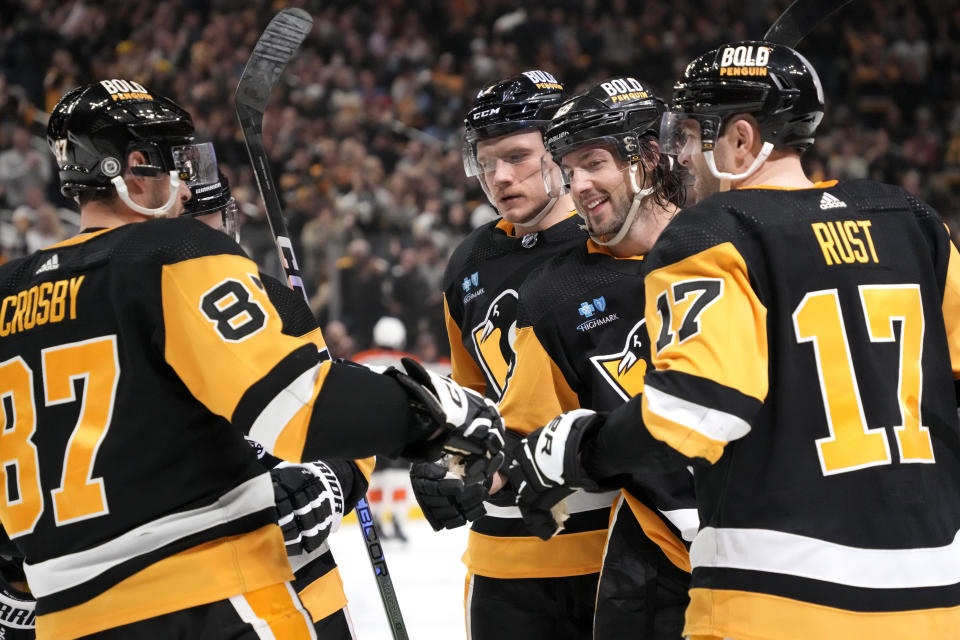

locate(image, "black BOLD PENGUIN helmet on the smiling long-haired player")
[[544, 77, 666, 164]]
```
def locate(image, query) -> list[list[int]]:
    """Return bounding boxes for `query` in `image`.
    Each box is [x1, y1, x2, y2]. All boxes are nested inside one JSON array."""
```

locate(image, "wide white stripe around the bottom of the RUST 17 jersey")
[[690, 527, 960, 589]]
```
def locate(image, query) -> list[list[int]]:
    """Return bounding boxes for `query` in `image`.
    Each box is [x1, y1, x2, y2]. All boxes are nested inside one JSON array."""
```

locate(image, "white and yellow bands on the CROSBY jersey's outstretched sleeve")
[[248, 360, 332, 462]]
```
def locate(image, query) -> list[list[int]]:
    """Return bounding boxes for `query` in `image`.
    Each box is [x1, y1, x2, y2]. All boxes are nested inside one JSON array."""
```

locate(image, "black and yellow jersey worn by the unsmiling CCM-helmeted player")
[[444, 212, 611, 578]]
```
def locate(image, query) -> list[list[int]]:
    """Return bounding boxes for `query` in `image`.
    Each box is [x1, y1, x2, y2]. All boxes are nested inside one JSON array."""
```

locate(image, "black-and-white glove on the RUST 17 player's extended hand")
[[510, 409, 599, 540]]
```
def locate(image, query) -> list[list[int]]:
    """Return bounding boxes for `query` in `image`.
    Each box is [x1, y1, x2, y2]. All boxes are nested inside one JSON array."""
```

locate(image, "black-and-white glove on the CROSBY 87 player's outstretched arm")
[[386, 358, 504, 485]]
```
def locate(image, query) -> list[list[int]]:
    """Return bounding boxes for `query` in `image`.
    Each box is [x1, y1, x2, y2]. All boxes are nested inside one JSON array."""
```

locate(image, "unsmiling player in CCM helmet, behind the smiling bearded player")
[[411, 71, 615, 640]]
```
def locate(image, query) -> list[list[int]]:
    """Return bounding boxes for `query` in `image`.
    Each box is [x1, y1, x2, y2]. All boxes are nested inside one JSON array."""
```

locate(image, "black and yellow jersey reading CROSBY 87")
[[0, 218, 420, 638]]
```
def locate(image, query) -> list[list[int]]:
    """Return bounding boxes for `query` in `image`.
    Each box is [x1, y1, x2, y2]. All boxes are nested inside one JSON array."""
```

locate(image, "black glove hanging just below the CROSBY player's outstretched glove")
[[410, 462, 488, 531]]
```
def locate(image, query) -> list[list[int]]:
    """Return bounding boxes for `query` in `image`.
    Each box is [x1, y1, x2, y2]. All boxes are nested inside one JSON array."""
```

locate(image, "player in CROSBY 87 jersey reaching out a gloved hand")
[[0, 80, 500, 640]]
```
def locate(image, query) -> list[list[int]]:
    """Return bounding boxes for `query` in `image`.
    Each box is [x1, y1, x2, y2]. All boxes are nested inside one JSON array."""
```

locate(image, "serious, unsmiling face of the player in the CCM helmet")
[[477, 130, 549, 224]]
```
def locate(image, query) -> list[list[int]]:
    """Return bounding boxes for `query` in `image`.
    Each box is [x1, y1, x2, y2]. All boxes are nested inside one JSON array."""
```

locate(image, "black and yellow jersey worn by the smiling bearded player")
[[500, 239, 698, 571]]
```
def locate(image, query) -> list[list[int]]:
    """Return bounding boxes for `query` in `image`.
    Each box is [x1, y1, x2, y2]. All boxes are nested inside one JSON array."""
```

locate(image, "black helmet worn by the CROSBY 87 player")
[[47, 80, 197, 197]]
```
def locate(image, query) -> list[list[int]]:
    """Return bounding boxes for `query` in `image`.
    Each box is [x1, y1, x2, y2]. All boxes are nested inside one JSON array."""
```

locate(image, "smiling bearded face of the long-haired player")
[[561, 146, 636, 236]]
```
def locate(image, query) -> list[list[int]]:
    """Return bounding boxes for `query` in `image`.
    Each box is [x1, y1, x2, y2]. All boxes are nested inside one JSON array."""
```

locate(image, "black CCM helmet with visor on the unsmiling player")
[[463, 70, 563, 177]]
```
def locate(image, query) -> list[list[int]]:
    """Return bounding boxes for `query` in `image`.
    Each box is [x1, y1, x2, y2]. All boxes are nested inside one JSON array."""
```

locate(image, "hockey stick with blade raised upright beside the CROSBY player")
[[236, 8, 407, 640]]
